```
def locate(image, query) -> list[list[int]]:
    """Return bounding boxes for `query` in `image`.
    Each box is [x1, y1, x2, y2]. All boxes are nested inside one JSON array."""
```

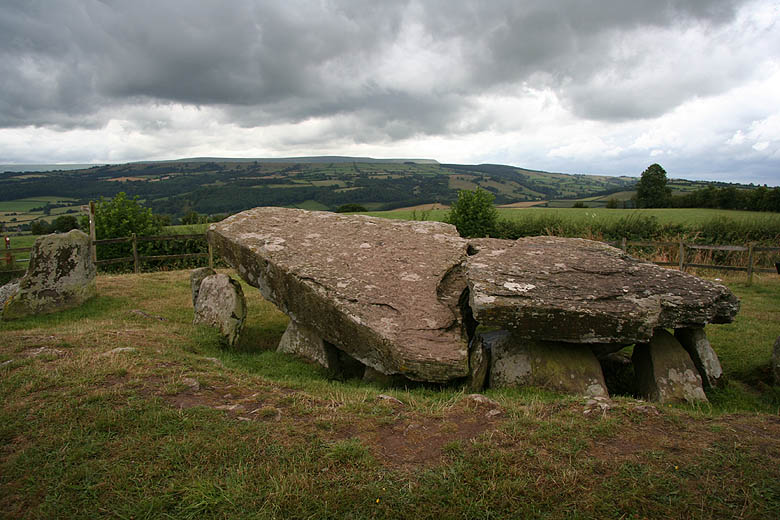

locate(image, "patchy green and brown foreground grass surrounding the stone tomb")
[[0, 271, 780, 519]]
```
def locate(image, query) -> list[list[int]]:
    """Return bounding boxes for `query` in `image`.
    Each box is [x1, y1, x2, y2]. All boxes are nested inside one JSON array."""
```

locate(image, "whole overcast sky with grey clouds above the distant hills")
[[0, 0, 780, 185]]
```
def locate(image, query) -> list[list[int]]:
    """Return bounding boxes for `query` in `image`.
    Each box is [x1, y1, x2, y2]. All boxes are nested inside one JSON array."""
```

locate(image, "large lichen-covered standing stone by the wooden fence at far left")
[[3, 229, 96, 320]]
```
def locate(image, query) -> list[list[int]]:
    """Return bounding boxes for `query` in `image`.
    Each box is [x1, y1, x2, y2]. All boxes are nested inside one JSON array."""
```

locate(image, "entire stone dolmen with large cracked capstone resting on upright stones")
[[207, 207, 739, 402]]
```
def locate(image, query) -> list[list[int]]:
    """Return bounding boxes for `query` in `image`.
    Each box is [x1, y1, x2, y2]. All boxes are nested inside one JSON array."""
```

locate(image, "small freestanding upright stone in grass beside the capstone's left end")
[[193, 274, 246, 346]]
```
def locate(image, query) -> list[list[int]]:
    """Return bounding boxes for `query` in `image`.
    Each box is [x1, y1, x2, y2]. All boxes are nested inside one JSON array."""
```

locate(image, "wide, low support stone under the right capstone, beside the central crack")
[[490, 335, 609, 396]]
